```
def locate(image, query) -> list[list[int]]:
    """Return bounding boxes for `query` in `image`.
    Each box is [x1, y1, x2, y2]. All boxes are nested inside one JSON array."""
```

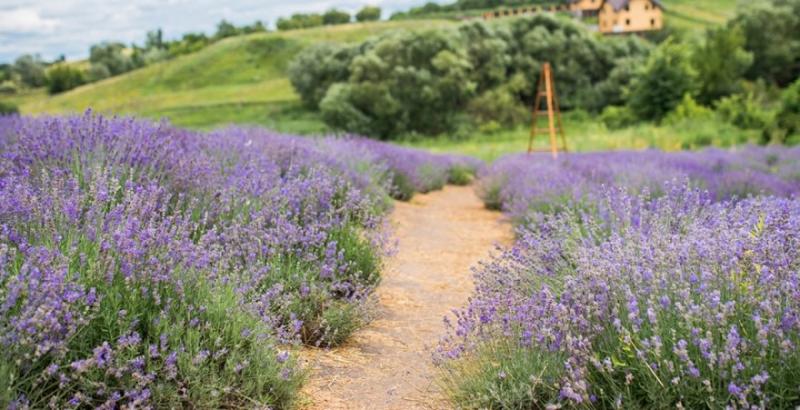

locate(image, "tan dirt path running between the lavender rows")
[[303, 187, 511, 409]]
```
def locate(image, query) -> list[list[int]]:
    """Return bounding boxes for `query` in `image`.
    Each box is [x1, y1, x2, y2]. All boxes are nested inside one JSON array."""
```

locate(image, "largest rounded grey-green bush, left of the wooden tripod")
[[320, 30, 476, 139]]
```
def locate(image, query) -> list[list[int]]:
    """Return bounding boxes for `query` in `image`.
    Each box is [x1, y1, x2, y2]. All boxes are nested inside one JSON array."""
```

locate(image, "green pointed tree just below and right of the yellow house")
[[628, 40, 696, 121]]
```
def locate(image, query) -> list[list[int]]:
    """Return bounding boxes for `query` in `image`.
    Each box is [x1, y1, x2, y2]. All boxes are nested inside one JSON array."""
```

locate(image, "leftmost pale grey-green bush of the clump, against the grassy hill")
[[288, 43, 357, 109]]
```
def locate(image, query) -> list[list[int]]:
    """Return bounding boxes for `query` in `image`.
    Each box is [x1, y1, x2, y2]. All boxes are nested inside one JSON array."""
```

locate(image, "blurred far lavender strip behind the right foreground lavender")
[[479, 147, 800, 223]]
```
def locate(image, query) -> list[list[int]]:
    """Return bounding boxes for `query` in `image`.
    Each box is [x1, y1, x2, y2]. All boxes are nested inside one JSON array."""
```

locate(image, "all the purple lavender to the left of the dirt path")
[[0, 113, 472, 409]]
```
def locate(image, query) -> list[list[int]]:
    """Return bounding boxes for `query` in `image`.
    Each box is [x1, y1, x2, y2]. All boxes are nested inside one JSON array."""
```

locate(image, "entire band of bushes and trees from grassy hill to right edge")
[[289, 0, 800, 142]]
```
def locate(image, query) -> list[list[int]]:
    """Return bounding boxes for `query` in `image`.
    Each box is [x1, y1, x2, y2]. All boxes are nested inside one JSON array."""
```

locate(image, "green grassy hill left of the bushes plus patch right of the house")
[[7, 0, 736, 133]]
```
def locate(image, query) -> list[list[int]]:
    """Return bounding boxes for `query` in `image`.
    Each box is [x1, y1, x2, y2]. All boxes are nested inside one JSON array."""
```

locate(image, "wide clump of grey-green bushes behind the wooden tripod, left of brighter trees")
[[290, 15, 648, 139]]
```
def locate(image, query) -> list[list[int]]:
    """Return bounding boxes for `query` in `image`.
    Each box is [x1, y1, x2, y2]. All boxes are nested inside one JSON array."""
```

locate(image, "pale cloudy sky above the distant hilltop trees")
[[0, 0, 444, 62]]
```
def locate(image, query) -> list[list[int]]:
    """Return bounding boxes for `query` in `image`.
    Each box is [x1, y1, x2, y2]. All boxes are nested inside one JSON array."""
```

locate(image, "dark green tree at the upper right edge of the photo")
[[728, 0, 800, 86]]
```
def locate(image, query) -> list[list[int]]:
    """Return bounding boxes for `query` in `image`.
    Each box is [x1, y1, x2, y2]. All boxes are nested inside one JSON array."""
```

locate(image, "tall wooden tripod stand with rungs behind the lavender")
[[528, 63, 567, 159]]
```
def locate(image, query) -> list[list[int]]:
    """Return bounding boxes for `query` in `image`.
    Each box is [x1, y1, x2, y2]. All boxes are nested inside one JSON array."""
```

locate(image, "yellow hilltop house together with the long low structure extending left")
[[483, 0, 664, 34]]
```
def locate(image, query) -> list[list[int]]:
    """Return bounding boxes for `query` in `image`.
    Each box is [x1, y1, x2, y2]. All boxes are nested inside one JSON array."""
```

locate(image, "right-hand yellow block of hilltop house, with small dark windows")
[[597, 0, 664, 33]]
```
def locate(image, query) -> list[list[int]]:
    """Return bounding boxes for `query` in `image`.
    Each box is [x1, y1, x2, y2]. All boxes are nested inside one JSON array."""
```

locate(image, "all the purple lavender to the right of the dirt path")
[[438, 148, 800, 408]]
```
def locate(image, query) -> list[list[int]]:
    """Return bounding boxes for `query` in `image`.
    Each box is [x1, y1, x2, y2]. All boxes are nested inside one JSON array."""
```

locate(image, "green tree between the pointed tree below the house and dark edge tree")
[[692, 26, 753, 105]]
